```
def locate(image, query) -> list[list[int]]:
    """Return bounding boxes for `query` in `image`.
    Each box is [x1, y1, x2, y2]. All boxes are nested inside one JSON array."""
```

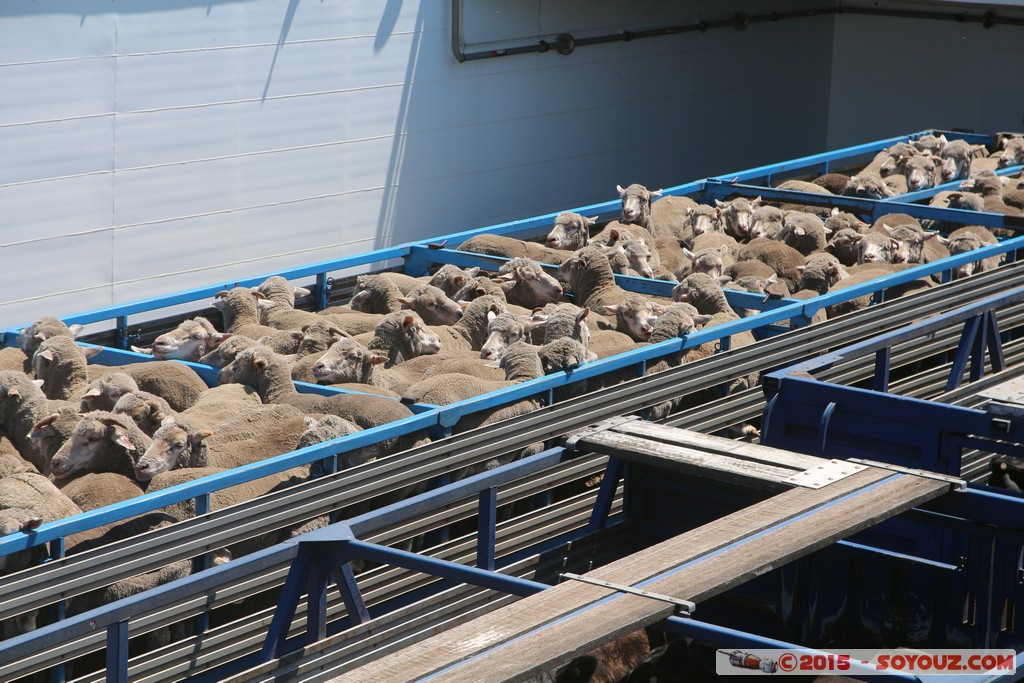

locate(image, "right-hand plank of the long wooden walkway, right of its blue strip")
[[431, 475, 950, 683]]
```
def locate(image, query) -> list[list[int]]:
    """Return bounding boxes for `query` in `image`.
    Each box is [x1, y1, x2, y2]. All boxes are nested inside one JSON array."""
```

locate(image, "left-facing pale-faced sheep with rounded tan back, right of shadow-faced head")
[[134, 405, 309, 482]]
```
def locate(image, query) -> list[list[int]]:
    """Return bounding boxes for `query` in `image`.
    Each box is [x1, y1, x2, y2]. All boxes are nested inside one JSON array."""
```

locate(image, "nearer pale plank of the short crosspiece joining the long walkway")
[[586, 431, 801, 490]]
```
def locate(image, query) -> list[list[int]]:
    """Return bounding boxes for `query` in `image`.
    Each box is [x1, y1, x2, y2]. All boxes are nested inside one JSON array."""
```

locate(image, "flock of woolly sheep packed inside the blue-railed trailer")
[[0, 136, 1024, 679]]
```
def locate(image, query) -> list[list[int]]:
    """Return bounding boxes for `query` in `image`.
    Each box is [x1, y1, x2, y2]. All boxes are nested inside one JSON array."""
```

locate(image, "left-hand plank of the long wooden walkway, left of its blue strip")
[[337, 468, 898, 682]]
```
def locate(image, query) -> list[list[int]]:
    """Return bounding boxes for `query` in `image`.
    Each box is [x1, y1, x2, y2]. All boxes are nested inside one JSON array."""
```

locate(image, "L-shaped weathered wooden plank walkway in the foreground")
[[338, 422, 954, 683]]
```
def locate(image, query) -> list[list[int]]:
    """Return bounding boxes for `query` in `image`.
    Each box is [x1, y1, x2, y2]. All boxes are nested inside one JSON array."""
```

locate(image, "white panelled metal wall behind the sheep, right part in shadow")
[[0, 0, 1019, 327]]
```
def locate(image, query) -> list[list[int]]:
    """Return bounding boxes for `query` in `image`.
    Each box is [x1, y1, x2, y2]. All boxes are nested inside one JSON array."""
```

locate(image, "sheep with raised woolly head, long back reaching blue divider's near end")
[[218, 348, 422, 453]]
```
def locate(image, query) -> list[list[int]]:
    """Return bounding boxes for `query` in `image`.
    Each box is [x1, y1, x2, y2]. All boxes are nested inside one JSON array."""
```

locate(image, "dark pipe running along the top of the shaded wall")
[[452, 0, 1024, 61]]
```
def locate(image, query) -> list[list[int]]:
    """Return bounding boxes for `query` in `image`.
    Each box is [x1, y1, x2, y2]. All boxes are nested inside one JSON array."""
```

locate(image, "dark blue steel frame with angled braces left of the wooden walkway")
[[8, 438, 1024, 682]]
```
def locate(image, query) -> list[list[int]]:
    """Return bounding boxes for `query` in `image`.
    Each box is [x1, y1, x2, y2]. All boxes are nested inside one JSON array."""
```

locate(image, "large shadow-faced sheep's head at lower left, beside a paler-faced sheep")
[[50, 411, 151, 479]]
